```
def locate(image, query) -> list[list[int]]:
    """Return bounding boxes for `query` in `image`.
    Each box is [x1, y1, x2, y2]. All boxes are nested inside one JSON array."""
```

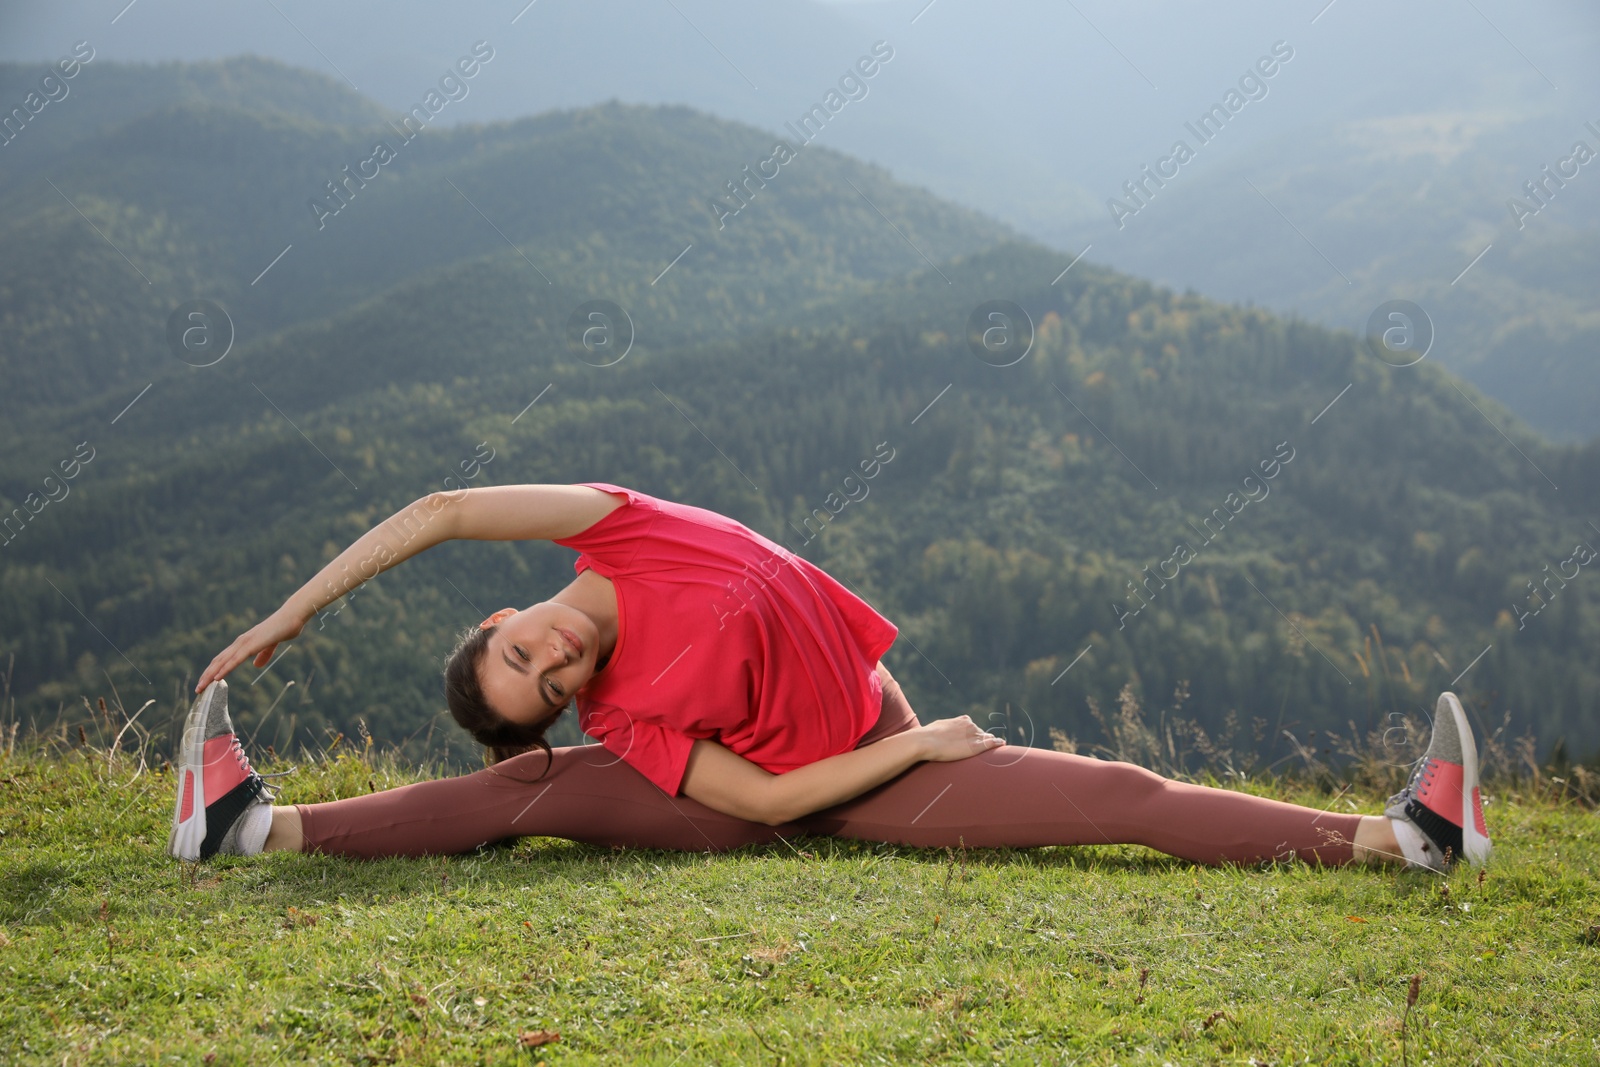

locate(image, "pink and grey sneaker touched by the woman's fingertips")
[[166, 678, 274, 862]]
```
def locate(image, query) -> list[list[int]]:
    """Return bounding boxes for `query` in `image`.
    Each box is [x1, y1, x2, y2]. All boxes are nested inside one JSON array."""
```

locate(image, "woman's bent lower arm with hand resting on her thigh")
[[680, 715, 1005, 825]]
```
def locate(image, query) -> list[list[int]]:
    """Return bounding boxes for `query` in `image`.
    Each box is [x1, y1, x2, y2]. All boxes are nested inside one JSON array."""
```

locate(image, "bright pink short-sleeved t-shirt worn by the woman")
[[557, 482, 899, 795]]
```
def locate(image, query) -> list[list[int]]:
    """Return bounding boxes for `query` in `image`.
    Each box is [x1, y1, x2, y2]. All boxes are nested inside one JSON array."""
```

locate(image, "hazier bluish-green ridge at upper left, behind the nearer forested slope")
[[0, 61, 1008, 419]]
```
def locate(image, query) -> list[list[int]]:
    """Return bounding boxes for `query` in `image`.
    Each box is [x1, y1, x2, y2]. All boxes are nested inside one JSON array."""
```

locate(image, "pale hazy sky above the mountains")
[[0, 0, 1600, 202]]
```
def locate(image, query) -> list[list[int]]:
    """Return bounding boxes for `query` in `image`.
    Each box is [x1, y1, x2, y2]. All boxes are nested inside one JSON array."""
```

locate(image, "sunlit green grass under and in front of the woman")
[[0, 749, 1600, 1067]]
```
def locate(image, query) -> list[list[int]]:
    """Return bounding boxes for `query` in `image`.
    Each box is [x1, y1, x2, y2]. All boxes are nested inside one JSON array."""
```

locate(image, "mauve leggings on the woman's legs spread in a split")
[[298, 670, 1362, 864]]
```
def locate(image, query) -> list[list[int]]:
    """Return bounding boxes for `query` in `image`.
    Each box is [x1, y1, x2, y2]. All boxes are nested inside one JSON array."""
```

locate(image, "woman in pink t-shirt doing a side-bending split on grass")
[[168, 483, 1490, 870]]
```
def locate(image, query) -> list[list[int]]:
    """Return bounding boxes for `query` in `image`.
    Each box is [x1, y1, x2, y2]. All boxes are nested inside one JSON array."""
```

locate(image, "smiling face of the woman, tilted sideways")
[[478, 600, 600, 725]]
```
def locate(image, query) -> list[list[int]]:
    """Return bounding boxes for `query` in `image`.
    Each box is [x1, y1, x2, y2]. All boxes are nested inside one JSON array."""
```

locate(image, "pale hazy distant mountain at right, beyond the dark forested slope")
[[1088, 110, 1600, 440]]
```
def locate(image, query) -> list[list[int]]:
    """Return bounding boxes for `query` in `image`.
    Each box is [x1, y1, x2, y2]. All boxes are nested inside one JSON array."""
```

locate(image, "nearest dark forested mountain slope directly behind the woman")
[[0, 245, 1600, 764]]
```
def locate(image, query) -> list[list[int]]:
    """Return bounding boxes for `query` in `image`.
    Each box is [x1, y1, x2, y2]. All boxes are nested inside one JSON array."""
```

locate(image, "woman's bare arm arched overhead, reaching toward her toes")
[[195, 485, 621, 693]]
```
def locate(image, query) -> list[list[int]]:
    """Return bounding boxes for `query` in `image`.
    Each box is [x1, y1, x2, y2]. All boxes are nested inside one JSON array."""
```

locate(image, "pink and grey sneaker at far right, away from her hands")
[[1384, 693, 1490, 870]]
